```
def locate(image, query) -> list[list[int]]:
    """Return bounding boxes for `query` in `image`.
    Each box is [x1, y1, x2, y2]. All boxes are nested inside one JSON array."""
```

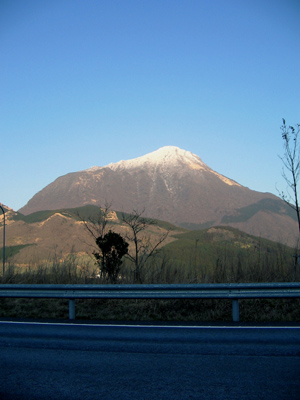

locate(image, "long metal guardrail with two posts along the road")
[[0, 282, 300, 322]]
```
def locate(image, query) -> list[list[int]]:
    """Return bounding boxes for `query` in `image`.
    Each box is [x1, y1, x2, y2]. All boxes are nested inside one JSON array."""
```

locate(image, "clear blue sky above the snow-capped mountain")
[[0, 0, 300, 210]]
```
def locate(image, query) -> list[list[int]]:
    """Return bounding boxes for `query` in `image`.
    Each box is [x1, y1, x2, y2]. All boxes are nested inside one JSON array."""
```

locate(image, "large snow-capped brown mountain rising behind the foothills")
[[19, 146, 297, 245]]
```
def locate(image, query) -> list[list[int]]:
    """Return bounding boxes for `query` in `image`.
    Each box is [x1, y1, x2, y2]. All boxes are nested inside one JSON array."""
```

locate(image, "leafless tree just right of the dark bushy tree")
[[122, 210, 170, 283]]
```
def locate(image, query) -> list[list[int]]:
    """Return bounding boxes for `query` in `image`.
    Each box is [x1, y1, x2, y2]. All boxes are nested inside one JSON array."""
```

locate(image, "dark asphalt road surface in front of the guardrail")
[[0, 322, 300, 400]]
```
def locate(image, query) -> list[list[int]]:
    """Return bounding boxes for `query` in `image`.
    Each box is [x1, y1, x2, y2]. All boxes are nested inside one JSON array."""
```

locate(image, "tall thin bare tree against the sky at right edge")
[[279, 118, 300, 234]]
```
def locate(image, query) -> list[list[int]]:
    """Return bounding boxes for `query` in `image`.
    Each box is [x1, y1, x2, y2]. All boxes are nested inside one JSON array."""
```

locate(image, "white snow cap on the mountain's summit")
[[107, 146, 207, 170]]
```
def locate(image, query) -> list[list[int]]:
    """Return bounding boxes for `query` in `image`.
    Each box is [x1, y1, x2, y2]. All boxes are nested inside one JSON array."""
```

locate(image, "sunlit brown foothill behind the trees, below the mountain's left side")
[[0, 206, 186, 265]]
